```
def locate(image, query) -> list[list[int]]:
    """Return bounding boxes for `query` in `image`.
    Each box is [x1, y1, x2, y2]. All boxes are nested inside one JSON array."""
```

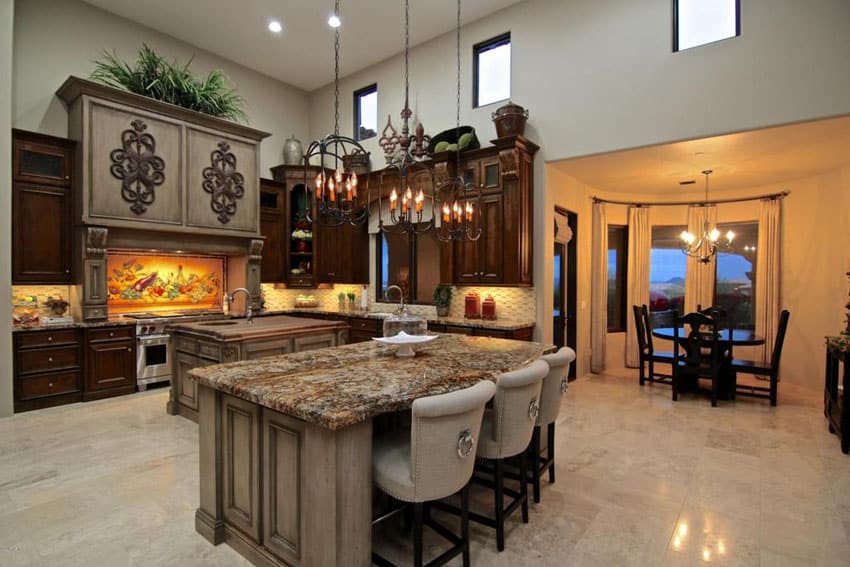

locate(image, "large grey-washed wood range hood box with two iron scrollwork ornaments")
[[57, 77, 268, 236]]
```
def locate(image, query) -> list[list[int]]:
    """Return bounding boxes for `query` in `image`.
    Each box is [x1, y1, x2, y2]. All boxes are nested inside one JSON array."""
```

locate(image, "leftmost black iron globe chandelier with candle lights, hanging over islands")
[[304, 0, 369, 227]]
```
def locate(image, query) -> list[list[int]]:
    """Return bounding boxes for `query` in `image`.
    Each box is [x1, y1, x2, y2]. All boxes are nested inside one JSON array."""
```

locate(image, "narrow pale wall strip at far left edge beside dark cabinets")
[[0, 0, 14, 417]]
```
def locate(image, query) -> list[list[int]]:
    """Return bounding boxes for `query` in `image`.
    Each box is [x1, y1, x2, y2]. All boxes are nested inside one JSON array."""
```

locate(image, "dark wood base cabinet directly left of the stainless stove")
[[83, 325, 136, 401]]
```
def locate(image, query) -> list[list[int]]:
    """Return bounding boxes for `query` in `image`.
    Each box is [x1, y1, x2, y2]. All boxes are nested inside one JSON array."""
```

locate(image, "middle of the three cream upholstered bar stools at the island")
[[434, 360, 549, 551]]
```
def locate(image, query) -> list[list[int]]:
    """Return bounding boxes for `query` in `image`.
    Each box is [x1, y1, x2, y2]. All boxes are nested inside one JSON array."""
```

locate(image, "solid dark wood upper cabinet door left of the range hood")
[[12, 183, 71, 283]]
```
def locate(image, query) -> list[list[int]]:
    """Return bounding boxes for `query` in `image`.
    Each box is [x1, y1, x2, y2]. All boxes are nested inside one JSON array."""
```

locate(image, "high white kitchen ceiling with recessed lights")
[[84, 0, 520, 91]]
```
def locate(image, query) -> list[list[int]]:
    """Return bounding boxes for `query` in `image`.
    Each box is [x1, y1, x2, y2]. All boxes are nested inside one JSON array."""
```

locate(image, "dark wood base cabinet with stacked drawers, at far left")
[[14, 329, 83, 413]]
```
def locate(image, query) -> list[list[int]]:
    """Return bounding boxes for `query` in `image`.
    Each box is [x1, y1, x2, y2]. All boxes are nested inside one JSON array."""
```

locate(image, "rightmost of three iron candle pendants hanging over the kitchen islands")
[[436, 0, 481, 242]]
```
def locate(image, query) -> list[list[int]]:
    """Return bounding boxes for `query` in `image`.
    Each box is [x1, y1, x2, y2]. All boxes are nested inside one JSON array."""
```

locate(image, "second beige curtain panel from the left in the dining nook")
[[624, 207, 652, 368]]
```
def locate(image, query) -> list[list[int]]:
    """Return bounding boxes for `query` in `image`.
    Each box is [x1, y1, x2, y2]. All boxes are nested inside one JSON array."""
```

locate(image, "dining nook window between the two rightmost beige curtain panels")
[[714, 222, 759, 329]]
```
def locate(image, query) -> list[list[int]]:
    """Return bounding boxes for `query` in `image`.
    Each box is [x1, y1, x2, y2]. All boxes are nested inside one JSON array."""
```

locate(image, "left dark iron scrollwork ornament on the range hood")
[[109, 119, 165, 215]]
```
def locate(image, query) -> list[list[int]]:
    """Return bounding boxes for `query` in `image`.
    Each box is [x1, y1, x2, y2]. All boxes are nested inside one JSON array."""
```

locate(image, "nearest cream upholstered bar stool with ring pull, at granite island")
[[372, 380, 496, 567]]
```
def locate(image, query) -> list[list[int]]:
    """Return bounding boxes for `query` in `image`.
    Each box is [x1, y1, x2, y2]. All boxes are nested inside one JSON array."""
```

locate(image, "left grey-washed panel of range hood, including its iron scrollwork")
[[88, 100, 183, 224]]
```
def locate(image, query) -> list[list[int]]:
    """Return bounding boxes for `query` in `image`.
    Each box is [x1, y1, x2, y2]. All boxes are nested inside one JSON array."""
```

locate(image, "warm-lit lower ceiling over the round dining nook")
[[553, 116, 850, 196]]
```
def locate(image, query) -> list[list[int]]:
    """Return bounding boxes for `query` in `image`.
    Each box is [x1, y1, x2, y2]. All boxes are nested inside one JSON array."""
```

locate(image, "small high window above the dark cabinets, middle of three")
[[472, 32, 511, 108]]
